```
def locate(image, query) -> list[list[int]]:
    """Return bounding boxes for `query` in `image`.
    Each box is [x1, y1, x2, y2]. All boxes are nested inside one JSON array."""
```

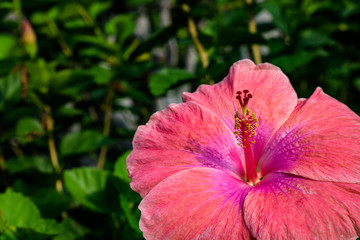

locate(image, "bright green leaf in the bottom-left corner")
[[0, 190, 61, 235]]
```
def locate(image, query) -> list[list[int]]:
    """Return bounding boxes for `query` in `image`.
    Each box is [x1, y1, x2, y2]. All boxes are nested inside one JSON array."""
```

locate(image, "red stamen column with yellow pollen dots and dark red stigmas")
[[234, 90, 258, 185]]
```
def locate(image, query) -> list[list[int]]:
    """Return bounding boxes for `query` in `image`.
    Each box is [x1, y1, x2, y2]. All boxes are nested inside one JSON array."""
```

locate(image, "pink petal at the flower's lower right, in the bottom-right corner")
[[244, 173, 360, 240]]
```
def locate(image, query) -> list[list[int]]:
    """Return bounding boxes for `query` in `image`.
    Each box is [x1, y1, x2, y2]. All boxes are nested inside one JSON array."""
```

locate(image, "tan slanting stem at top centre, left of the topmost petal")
[[182, 4, 209, 70]]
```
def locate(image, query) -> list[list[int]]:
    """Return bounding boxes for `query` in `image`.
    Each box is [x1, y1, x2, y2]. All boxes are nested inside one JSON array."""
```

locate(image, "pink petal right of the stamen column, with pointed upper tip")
[[259, 88, 360, 183]]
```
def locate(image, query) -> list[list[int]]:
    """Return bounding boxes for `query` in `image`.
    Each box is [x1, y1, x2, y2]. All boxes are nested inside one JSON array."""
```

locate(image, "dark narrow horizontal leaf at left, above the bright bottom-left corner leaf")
[[6, 156, 54, 174]]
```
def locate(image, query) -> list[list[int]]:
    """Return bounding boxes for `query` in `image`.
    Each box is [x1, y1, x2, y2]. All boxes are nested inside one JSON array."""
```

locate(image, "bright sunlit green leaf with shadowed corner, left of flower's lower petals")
[[64, 167, 117, 213]]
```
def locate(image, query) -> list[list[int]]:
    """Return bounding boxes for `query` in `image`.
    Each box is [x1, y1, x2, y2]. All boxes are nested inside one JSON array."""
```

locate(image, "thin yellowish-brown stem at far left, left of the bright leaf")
[[44, 105, 63, 192]]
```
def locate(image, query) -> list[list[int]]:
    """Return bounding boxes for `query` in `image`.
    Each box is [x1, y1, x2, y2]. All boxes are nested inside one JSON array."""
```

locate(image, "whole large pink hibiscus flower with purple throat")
[[127, 60, 360, 240]]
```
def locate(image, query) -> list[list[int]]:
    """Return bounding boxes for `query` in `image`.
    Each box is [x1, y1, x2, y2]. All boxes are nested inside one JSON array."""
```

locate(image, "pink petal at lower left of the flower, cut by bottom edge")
[[139, 168, 251, 240]]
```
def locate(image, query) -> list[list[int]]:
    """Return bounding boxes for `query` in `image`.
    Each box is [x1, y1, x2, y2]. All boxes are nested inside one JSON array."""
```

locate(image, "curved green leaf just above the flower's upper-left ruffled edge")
[[149, 68, 194, 96]]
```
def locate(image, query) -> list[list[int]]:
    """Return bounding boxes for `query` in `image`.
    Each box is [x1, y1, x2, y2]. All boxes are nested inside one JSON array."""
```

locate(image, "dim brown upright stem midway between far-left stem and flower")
[[98, 84, 114, 169]]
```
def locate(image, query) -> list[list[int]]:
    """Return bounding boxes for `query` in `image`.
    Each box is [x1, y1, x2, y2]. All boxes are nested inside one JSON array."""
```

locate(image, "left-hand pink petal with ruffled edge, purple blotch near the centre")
[[127, 102, 244, 197]]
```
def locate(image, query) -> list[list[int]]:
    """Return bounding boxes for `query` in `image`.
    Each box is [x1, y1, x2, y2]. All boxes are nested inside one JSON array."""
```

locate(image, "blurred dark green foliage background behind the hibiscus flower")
[[0, 0, 360, 240]]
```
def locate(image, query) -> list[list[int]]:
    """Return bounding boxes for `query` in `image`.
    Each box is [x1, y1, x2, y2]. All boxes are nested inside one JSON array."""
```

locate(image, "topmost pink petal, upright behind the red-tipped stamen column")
[[183, 60, 297, 165]]
